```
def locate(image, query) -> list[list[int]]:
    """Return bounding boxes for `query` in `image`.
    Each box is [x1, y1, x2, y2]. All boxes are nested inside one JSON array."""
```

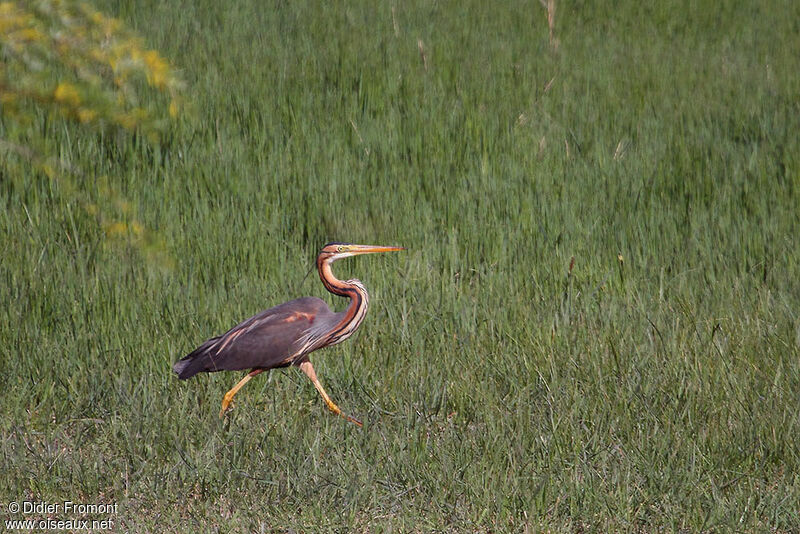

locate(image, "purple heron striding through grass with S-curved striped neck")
[[172, 242, 405, 427]]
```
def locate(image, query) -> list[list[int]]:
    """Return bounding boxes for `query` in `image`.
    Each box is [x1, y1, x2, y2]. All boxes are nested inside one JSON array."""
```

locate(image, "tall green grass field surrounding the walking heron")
[[0, 0, 800, 532]]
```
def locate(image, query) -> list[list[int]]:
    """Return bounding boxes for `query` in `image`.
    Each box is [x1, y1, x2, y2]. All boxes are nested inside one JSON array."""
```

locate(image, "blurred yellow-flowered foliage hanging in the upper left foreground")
[[0, 0, 183, 260]]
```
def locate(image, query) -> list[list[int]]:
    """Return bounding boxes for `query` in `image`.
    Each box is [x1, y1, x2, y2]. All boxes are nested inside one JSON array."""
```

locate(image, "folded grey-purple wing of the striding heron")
[[173, 297, 334, 378]]
